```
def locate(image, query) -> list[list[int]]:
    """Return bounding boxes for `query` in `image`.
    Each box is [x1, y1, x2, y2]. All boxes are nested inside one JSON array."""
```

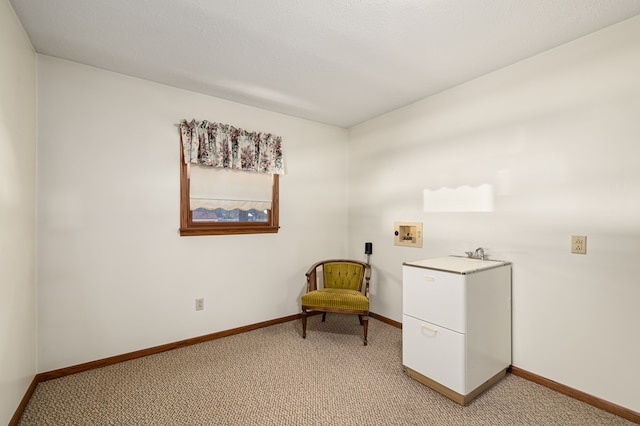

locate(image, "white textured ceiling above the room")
[[10, 0, 640, 128]]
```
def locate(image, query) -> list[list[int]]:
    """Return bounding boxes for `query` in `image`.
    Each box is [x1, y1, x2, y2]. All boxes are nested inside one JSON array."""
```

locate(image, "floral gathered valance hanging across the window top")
[[180, 120, 284, 174]]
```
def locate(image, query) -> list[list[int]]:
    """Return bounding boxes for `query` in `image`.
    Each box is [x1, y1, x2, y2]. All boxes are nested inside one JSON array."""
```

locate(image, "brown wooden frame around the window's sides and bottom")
[[180, 150, 280, 236]]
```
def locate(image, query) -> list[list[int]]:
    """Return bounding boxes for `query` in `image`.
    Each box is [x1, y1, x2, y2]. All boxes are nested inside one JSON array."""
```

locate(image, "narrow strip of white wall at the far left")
[[0, 0, 36, 424]]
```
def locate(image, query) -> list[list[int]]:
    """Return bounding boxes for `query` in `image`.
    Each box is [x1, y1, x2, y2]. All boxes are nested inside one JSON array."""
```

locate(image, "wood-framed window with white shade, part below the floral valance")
[[180, 160, 279, 236]]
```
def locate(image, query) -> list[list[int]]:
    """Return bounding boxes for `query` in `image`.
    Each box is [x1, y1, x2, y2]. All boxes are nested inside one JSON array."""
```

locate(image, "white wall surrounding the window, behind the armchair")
[[38, 56, 347, 372]]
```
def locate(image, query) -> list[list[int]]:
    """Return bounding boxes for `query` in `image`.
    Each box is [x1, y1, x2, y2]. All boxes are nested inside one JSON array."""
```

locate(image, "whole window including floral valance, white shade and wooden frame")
[[180, 120, 284, 235]]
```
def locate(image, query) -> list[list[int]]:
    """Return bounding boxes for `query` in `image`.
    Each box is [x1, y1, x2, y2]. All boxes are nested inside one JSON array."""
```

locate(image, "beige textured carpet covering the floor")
[[20, 314, 632, 426]]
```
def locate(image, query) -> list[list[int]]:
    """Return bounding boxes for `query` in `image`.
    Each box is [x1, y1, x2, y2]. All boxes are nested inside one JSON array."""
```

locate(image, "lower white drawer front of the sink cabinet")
[[402, 315, 468, 395]]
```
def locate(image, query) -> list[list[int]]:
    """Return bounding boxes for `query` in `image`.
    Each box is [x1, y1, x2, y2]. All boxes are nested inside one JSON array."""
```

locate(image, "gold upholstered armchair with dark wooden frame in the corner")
[[301, 259, 371, 346]]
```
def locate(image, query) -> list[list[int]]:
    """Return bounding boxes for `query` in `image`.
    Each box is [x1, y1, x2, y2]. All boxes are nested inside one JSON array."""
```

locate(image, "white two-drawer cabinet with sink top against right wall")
[[402, 256, 511, 405]]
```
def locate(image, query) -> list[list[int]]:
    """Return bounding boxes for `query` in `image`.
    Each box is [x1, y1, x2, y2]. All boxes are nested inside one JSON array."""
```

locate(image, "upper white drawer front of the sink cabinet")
[[402, 265, 467, 333]]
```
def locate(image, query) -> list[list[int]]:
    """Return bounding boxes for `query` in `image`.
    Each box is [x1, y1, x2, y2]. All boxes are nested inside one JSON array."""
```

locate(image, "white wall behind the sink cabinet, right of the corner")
[[349, 17, 640, 411]]
